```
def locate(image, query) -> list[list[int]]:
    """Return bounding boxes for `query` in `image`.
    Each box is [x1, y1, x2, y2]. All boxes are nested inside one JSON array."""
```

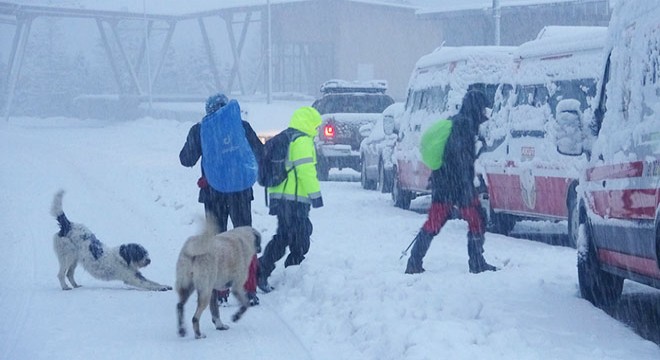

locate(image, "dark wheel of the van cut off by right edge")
[[577, 223, 623, 308]]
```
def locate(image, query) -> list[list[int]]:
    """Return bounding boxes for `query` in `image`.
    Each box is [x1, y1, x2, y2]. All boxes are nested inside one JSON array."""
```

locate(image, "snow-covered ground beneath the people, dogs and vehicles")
[[0, 100, 660, 360]]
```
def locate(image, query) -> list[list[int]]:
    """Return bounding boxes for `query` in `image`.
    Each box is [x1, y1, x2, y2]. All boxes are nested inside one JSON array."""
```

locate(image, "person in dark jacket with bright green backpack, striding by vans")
[[405, 90, 497, 274]]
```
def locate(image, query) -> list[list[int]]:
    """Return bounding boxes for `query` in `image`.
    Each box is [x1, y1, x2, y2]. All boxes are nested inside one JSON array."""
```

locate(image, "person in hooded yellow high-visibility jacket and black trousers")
[[257, 106, 323, 293]]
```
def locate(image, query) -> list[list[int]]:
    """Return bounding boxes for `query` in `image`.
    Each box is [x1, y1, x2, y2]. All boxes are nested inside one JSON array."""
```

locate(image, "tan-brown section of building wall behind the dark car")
[[272, 0, 442, 100]]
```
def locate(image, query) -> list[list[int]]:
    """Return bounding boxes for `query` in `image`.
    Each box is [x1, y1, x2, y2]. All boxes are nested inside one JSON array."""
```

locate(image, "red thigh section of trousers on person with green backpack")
[[422, 197, 485, 236]]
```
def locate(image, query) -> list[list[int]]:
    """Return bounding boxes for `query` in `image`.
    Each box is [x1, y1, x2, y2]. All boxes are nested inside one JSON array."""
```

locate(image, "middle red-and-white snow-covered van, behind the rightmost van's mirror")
[[477, 26, 607, 243]]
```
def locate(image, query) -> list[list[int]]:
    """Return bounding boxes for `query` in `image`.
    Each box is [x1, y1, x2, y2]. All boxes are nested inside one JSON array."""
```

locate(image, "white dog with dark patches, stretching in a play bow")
[[50, 190, 172, 291]]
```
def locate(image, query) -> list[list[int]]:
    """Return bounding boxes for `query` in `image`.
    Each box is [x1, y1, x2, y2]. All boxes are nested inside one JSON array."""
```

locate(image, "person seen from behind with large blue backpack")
[[179, 93, 263, 305]]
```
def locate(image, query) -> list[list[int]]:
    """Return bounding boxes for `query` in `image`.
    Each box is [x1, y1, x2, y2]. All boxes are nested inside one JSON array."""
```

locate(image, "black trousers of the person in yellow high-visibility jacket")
[[259, 201, 313, 278]]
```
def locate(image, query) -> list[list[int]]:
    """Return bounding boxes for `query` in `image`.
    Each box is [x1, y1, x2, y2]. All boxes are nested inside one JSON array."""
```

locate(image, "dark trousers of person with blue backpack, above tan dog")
[[204, 189, 253, 232]]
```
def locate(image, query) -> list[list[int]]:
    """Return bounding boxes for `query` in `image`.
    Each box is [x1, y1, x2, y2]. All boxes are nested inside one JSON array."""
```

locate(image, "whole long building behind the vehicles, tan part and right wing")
[[264, 0, 609, 101]]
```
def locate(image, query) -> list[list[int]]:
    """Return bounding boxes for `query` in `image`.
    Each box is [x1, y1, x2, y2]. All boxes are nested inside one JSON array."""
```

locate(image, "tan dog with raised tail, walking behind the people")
[[175, 217, 261, 339]]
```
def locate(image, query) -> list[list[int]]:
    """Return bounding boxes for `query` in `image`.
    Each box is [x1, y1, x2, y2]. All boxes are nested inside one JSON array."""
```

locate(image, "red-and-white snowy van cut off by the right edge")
[[558, 0, 660, 306]]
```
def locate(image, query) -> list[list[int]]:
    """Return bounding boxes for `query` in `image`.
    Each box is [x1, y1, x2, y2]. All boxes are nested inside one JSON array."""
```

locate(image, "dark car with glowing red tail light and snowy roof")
[[312, 80, 394, 181]]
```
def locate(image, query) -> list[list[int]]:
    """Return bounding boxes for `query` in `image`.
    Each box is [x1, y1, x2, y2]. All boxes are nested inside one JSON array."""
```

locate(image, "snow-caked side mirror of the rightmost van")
[[556, 99, 585, 156]]
